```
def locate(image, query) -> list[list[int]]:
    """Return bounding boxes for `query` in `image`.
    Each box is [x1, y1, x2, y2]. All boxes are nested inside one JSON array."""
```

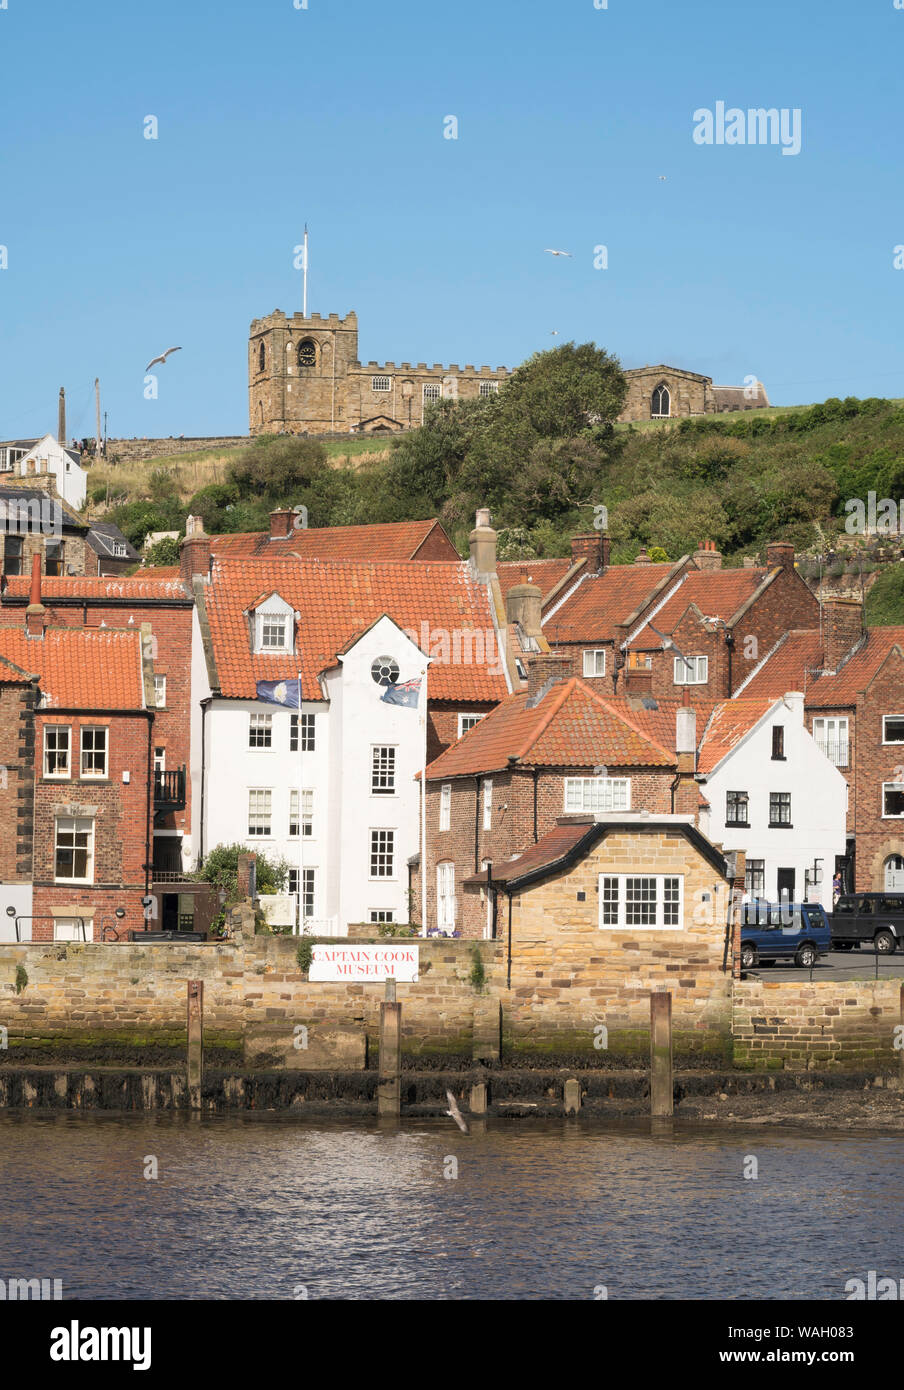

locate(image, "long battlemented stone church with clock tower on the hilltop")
[[248, 310, 769, 435]]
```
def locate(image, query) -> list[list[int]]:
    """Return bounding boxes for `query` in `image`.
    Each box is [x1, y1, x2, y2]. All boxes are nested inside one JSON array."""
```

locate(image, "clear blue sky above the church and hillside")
[[0, 0, 904, 438]]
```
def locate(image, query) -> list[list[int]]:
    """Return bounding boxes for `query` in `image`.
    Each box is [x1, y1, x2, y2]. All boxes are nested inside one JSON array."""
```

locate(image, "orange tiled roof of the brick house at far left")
[[0, 627, 145, 709]]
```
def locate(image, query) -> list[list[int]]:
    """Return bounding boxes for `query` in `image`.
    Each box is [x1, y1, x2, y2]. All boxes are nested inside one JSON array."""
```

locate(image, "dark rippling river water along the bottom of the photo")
[[0, 1112, 904, 1300]]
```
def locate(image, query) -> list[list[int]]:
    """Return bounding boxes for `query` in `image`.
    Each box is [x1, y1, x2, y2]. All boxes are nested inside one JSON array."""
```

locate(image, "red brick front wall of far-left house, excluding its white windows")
[[32, 710, 147, 941]]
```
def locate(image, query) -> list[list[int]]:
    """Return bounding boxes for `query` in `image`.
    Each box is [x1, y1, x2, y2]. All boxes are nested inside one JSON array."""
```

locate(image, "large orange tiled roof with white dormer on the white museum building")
[[206, 557, 508, 701]]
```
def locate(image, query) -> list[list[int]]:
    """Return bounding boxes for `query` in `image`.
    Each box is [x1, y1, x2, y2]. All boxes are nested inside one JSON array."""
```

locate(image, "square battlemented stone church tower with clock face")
[[248, 309, 357, 435]]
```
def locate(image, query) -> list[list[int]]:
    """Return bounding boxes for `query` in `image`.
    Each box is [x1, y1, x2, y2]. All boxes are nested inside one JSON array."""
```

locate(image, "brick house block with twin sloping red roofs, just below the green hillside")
[[544, 537, 819, 699]]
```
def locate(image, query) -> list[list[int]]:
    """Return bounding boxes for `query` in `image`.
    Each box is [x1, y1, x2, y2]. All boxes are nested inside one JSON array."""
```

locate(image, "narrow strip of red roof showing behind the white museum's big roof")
[[210, 518, 458, 562]]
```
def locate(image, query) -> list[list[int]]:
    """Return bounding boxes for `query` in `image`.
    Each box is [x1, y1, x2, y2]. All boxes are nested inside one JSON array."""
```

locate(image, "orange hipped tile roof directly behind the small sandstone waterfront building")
[[427, 676, 675, 780]]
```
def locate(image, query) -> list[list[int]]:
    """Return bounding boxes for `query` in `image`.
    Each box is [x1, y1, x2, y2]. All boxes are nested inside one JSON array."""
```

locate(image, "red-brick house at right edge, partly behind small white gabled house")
[[743, 598, 904, 891]]
